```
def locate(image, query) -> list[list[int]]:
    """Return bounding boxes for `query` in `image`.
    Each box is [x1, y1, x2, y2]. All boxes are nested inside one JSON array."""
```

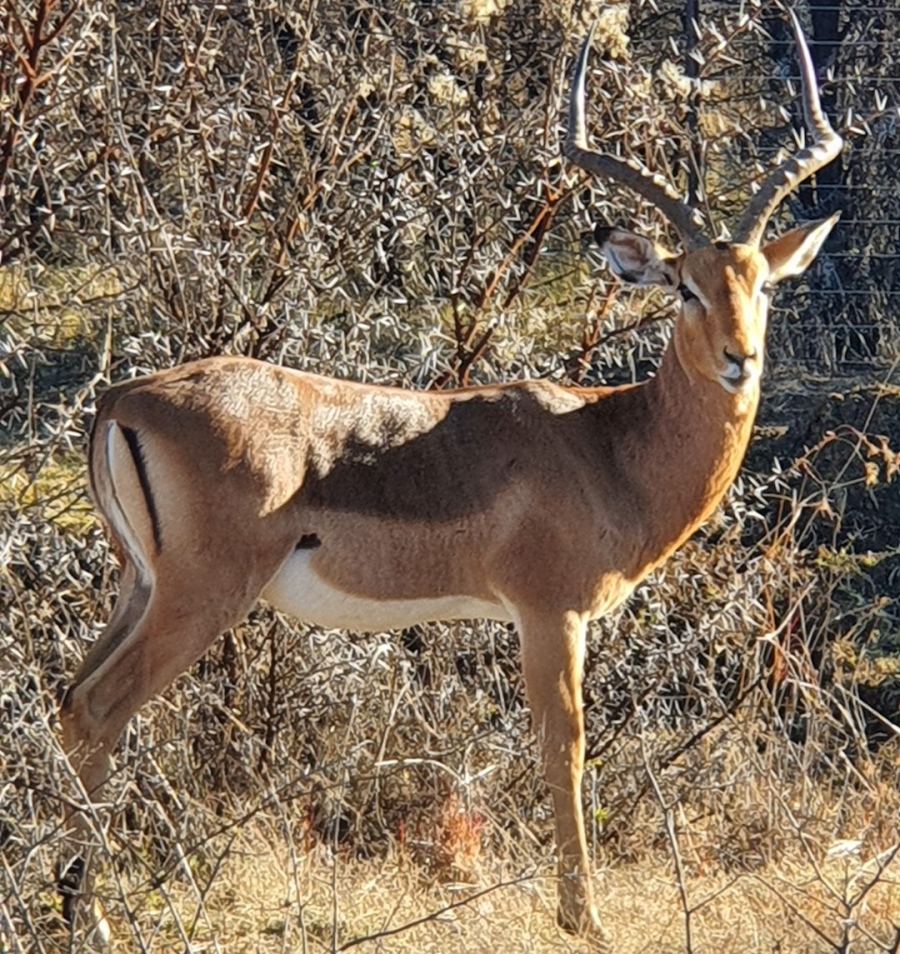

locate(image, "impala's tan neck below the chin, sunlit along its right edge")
[[632, 328, 759, 565]]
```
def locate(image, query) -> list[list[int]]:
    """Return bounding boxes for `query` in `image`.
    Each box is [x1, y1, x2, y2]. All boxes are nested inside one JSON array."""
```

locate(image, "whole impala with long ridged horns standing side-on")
[[62, 11, 842, 934]]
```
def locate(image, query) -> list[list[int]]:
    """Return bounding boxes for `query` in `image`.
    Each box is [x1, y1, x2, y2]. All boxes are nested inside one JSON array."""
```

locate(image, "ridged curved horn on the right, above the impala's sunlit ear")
[[734, 10, 844, 245]]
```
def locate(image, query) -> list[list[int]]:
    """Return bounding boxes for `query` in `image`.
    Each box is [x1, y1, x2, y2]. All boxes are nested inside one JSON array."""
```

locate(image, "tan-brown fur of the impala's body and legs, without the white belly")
[[58, 244, 764, 924]]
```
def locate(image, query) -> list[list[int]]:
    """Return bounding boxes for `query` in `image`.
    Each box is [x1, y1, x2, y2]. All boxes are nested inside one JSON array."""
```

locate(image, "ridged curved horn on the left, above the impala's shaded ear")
[[565, 26, 709, 249]]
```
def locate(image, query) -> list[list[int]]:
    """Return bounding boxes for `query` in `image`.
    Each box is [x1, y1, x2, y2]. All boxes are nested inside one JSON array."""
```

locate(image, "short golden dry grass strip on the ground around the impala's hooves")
[[19, 823, 900, 954]]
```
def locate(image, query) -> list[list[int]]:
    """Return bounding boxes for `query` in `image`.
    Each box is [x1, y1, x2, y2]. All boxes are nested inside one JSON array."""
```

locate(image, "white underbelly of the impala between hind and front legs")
[[262, 550, 511, 632]]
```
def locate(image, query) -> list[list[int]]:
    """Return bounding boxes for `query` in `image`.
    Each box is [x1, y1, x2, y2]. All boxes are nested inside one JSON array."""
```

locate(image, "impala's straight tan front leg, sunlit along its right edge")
[[519, 612, 606, 938]]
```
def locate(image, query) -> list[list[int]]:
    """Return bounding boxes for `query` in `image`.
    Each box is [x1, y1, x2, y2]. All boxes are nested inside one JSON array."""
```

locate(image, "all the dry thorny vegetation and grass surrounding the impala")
[[0, 0, 900, 954]]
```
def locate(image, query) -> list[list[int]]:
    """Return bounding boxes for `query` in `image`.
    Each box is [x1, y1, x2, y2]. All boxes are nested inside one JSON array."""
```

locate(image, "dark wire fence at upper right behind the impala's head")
[[634, 0, 900, 374]]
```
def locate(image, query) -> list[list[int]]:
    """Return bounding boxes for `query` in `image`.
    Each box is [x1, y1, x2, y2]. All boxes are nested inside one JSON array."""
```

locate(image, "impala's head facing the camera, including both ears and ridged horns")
[[565, 12, 843, 394]]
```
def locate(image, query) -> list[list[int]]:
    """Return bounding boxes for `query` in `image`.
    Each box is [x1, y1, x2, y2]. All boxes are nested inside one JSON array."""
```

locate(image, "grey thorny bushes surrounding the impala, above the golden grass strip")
[[0, 0, 900, 950]]
